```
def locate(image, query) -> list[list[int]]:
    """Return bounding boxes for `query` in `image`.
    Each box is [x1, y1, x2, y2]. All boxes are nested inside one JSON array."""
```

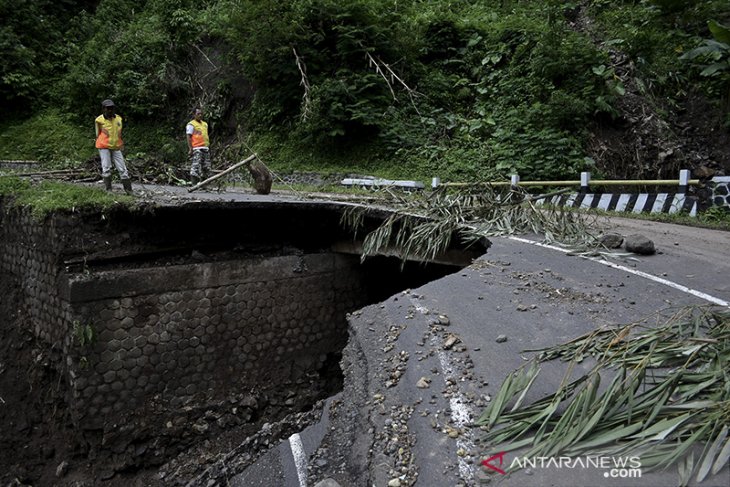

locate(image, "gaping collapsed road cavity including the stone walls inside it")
[[0, 200, 488, 484]]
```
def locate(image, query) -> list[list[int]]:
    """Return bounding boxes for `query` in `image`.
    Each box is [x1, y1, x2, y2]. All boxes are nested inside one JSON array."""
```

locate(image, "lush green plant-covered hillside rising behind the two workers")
[[0, 0, 730, 181]]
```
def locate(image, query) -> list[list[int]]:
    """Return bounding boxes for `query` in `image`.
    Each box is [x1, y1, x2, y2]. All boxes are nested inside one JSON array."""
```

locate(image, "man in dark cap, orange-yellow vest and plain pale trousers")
[[94, 100, 132, 194]]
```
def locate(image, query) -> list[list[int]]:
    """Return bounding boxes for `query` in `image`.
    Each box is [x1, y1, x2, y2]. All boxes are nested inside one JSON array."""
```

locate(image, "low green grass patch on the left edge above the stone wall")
[[0, 175, 135, 220]]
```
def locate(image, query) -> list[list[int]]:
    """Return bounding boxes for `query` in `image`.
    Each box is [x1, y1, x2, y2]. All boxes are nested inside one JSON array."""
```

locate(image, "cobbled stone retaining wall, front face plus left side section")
[[0, 198, 366, 436]]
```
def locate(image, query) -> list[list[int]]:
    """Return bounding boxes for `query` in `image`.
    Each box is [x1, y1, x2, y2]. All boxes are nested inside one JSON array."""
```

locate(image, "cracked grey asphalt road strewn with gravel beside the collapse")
[[232, 219, 730, 487]]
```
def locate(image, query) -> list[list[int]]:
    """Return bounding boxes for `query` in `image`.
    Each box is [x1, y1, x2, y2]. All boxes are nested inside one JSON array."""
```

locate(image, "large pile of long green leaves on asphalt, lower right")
[[477, 307, 730, 485]]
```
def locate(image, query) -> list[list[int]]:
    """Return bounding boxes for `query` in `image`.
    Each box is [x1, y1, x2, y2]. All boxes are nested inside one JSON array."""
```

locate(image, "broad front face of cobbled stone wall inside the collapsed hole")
[[63, 254, 363, 427]]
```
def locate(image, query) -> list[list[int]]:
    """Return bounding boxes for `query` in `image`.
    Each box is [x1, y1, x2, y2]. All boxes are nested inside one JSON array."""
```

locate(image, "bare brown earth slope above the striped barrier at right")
[[570, 1, 730, 183]]
